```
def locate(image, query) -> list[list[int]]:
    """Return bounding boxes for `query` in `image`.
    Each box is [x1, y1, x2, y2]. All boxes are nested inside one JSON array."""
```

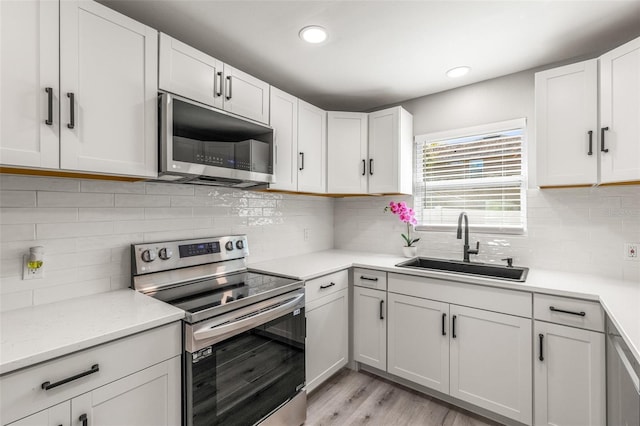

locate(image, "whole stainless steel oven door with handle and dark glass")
[[184, 289, 306, 426]]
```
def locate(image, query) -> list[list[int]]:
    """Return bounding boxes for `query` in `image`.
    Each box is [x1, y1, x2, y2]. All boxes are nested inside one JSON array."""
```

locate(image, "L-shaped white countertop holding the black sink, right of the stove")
[[249, 250, 640, 362]]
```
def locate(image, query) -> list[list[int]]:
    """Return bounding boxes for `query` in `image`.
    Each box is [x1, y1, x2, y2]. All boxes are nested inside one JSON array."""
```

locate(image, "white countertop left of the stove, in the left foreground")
[[0, 289, 184, 374]]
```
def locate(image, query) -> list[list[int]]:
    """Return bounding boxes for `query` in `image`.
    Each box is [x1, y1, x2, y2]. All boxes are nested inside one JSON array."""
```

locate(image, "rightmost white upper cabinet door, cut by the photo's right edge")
[[600, 38, 640, 183]]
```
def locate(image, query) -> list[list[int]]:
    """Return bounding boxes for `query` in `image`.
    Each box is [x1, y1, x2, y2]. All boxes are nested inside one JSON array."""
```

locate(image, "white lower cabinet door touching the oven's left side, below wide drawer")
[[71, 356, 181, 426]]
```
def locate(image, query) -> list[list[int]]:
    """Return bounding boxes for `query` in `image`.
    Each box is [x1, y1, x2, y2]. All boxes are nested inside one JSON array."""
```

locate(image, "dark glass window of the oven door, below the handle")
[[186, 308, 305, 426]]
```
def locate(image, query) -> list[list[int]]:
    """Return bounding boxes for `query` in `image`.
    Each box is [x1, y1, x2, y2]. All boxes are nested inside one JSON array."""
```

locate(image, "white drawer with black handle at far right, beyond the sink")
[[533, 294, 604, 332]]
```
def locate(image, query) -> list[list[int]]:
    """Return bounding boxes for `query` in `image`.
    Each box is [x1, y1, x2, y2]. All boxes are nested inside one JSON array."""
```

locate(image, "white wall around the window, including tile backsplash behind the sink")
[[334, 71, 640, 282]]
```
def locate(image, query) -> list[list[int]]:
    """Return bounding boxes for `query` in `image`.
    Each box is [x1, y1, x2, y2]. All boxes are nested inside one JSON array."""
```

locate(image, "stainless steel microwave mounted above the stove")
[[158, 93, 275, 189]]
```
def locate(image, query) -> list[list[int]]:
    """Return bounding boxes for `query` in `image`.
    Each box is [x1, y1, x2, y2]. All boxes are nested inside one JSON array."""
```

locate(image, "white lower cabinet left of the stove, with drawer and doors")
[[0, 322, 182, 426]]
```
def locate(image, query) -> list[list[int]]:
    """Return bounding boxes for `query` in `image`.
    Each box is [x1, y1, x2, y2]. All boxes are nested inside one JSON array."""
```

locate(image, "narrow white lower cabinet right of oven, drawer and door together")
[[305, 270, 349, 392]]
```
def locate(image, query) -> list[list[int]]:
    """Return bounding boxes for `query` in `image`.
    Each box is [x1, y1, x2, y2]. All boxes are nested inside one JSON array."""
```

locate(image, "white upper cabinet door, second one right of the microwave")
[[297, 100, 327, 193]]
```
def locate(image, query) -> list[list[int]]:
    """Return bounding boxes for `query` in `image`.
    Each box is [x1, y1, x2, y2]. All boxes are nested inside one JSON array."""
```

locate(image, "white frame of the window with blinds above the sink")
[[413, 118, 529, 235]]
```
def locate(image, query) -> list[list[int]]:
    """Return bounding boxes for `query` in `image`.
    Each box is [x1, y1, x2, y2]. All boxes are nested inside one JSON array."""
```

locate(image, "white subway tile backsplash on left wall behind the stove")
[[0, 175, 333, 310]]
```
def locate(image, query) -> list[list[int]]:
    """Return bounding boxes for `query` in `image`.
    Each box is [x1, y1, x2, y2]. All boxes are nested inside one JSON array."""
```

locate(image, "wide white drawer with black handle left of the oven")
[[0, 322, 182, 424]]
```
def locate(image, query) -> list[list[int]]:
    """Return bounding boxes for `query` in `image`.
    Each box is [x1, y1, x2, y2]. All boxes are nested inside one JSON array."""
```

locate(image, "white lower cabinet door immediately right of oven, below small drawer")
[[305, 289, 349, 392]]
